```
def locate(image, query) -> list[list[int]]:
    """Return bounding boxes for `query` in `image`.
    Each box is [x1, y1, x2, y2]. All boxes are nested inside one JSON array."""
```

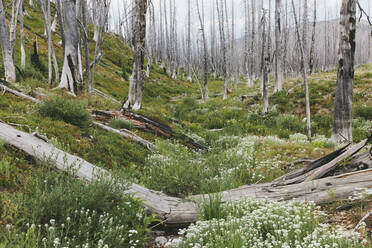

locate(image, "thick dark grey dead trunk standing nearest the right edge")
[[332, 0, 356, 143]]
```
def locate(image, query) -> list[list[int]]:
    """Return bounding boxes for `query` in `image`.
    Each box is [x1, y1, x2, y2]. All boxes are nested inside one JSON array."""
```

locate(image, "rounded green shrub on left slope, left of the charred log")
[[37, 97, 92, 128]]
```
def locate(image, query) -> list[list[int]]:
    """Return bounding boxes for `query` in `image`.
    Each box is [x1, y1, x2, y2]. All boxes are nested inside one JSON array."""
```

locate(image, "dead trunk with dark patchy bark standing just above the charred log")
[[122, 0, 147, 110]]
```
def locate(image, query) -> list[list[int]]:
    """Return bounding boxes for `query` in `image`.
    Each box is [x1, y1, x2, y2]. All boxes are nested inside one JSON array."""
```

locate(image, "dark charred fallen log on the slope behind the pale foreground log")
[[92, 110, 209, 150]]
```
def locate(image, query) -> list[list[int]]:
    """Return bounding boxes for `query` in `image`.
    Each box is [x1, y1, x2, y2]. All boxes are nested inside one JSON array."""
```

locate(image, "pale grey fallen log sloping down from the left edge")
[[0, 122, 197, 226]]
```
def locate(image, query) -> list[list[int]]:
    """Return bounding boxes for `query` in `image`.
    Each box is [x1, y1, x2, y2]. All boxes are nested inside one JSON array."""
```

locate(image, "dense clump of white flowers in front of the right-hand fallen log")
[[170, 199, 370, 248]]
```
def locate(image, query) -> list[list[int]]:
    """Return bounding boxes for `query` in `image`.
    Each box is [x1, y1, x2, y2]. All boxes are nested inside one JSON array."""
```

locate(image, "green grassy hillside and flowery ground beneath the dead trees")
[[0, 1, 372, 247]]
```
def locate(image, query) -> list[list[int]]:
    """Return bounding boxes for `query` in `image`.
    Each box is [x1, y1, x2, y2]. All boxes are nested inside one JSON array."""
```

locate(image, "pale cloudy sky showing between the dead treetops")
[[111, 0, 372, 38]]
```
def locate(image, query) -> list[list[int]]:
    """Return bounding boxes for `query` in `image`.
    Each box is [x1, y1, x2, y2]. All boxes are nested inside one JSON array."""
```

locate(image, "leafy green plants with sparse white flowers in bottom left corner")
[[1, 164, 154, 247]]
